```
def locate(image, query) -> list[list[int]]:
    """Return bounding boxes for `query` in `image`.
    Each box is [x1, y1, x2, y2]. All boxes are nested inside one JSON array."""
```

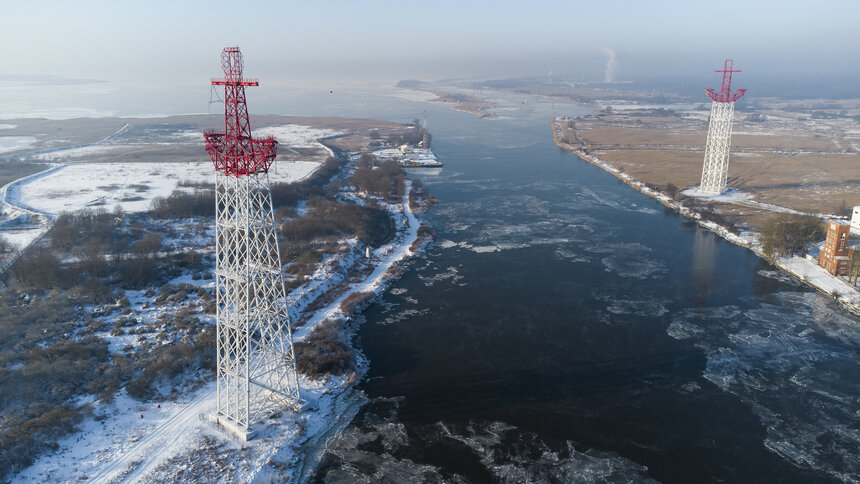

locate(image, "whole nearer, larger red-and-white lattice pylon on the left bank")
[[203, 47, 301, 439]]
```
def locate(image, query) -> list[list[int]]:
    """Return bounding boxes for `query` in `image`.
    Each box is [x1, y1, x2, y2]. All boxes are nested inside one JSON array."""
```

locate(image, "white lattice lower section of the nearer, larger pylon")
[[215, 173, 300, 437]]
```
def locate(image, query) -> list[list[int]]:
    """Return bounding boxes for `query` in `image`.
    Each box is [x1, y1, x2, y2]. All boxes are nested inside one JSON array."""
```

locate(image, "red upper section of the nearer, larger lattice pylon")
[[203, 47, 278, 176]]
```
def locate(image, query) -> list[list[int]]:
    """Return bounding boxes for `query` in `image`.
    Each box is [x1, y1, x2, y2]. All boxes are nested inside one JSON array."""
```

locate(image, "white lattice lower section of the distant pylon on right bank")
[[699, 101, 735, 195]]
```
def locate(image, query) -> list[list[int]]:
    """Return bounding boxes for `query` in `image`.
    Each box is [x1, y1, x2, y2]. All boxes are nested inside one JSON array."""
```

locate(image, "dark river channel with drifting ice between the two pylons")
[[310, 91, 860, 482]]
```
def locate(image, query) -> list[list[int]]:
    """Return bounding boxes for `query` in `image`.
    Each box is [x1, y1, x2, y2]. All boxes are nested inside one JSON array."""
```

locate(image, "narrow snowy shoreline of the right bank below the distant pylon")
[[550, 117, 860, 315]]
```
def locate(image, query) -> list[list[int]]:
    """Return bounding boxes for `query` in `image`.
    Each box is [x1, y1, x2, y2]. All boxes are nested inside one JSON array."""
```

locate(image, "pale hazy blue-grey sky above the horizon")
[[0, 0, 860, 85]]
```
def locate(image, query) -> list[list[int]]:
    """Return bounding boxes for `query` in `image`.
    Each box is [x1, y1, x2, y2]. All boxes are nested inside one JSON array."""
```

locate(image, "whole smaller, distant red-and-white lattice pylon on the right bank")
[[699, 59, 747, 195]]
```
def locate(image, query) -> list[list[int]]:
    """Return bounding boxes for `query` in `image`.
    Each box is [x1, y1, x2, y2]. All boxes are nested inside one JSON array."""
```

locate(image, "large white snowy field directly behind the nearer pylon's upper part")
[[6, 160, 320, 214]]
